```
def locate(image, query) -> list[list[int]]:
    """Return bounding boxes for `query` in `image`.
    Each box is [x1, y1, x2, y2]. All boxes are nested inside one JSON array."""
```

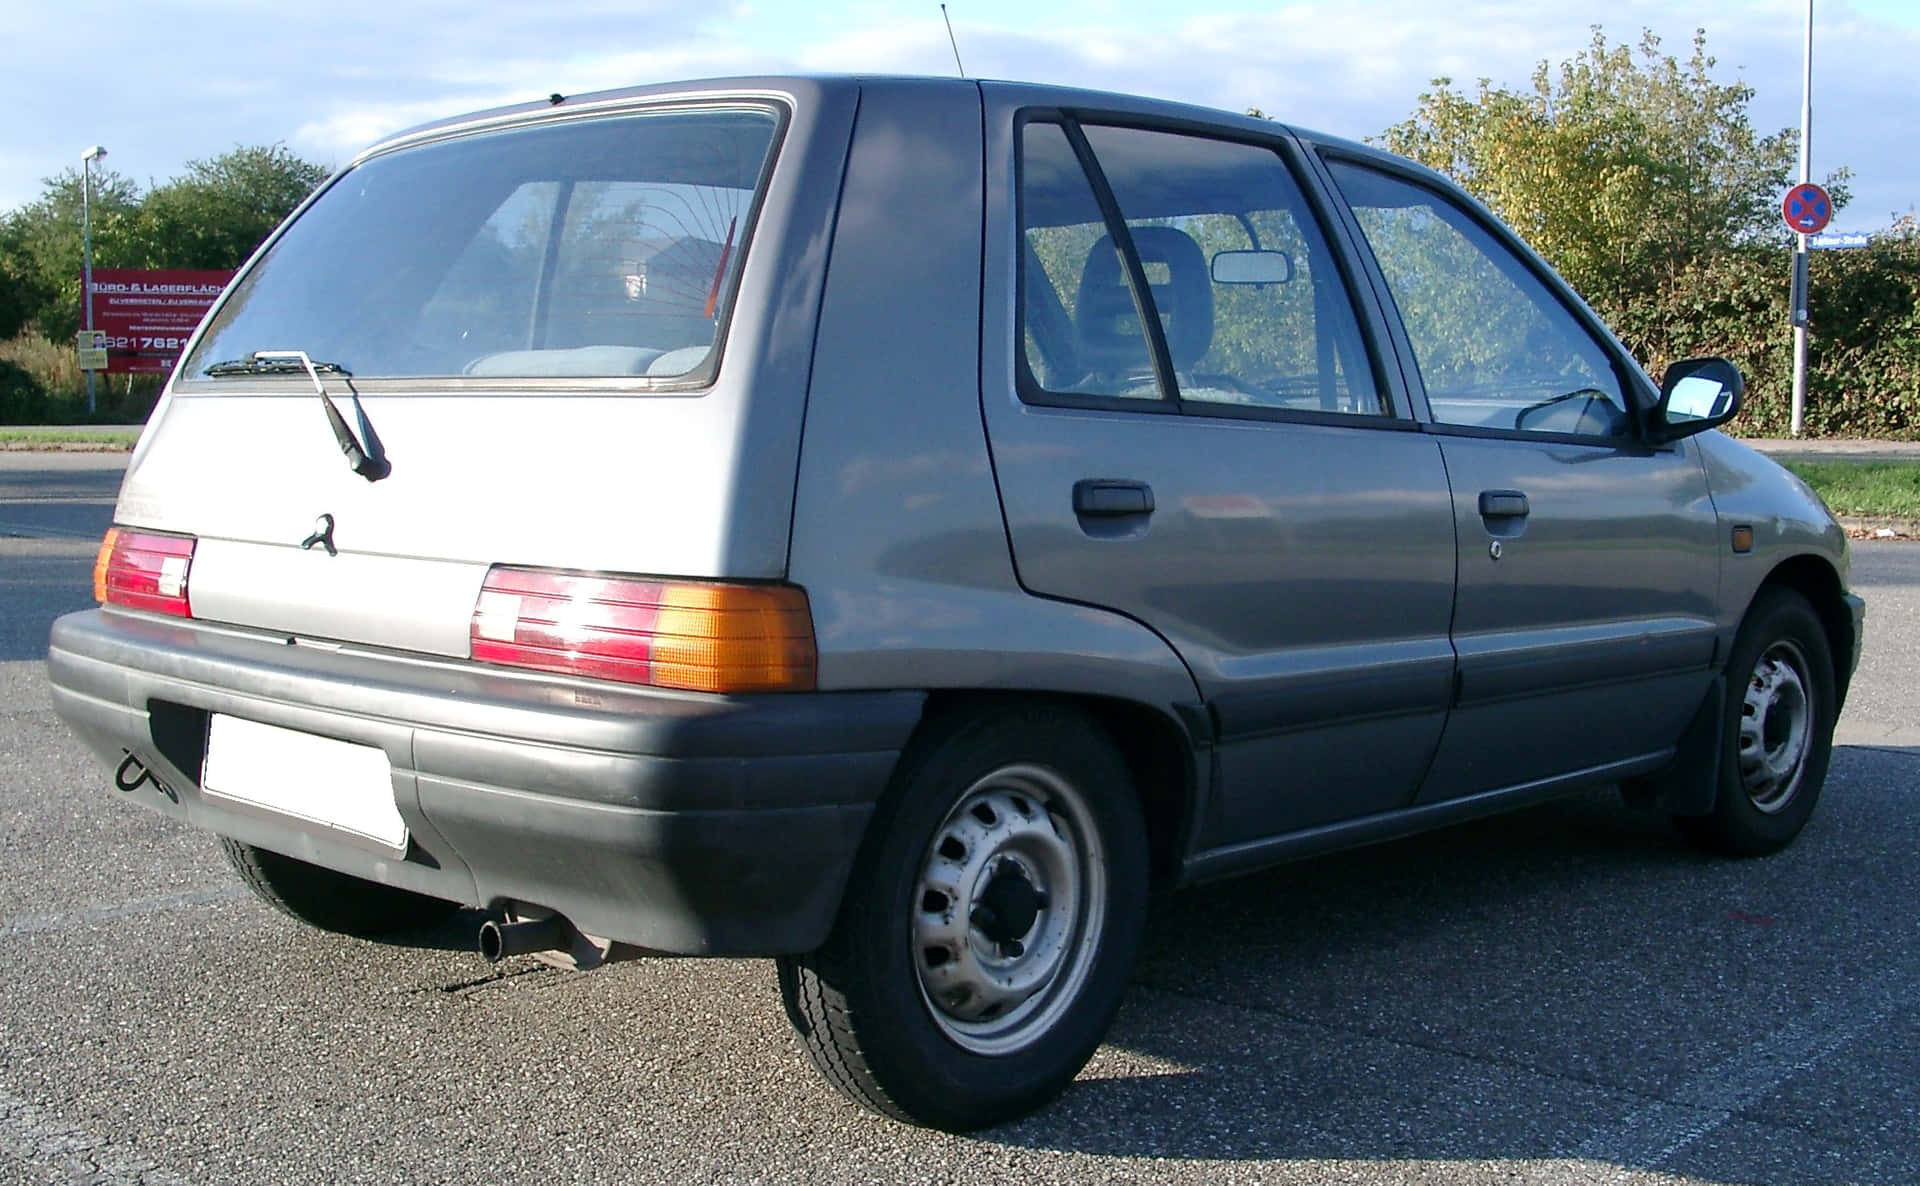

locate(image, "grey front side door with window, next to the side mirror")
[[1329, 157, 1718, 802]]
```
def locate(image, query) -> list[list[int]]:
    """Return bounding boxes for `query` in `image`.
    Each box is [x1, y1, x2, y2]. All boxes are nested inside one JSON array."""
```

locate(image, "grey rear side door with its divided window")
[[983, 88, 1453, 850]]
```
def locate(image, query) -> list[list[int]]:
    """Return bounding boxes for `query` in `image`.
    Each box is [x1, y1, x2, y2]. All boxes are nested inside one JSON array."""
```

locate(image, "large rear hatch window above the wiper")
[[180, 104, 781, 386]]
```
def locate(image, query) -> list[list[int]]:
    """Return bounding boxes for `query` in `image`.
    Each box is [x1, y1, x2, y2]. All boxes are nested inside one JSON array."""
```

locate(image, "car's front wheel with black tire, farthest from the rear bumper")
[[1674, 589, 1837, 856]]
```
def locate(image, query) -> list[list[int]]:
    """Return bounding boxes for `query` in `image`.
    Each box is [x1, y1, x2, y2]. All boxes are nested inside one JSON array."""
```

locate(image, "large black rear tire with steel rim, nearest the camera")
[[780, 706, 1148, 1132]]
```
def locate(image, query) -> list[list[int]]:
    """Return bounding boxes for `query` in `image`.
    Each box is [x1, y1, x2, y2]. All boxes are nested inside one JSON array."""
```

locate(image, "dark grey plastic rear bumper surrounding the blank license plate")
[[46, 610, 924, 956]]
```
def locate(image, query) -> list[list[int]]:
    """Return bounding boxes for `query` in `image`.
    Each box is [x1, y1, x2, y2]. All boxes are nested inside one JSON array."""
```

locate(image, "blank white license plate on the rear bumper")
[[200, 714, 407, 856]]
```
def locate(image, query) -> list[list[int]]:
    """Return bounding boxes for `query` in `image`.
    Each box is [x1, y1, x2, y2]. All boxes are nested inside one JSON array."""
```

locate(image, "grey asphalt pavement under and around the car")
[[0, 453, 1920, 1186]]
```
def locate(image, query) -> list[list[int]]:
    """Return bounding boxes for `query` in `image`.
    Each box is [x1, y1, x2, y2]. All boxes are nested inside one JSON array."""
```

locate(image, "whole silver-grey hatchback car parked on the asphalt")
[[48, 79, 1862, 1128]]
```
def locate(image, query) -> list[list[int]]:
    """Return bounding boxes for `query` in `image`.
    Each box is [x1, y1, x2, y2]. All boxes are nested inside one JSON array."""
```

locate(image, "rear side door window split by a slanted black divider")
[[1021, 114, 1382, 415]]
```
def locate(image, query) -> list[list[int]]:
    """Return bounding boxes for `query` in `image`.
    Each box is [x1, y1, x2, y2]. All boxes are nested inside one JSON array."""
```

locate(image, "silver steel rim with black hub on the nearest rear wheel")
[[908, 764, 1108, 1056]]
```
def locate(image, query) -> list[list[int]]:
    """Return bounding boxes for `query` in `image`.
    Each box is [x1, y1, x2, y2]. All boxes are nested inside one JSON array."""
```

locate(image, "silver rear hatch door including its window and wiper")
[[117, 84, 854, 654]]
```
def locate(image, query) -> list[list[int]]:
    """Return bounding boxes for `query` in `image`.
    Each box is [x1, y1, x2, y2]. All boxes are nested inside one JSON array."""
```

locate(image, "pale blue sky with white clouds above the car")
[[0, 0, 1920, 230]]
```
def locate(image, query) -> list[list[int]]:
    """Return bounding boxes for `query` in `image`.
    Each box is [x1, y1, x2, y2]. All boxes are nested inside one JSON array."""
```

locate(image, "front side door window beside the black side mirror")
[[1329, 161, 1630, 438]]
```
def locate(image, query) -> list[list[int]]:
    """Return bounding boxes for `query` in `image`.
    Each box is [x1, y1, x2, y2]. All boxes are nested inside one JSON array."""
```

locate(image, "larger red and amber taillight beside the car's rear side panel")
[[468, 566, 814, 693]]
